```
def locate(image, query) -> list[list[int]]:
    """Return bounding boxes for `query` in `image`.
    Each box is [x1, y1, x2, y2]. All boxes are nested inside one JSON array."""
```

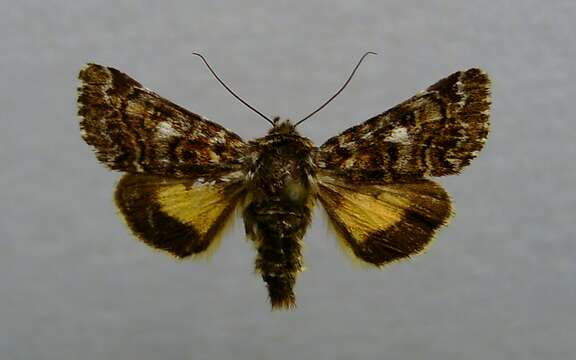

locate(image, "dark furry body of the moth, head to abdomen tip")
[[243, 120, 317, 308]]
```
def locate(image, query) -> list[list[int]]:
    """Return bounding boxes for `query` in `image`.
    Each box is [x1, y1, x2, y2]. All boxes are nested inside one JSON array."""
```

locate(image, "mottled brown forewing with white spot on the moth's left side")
[[78, 64, 244, 176]]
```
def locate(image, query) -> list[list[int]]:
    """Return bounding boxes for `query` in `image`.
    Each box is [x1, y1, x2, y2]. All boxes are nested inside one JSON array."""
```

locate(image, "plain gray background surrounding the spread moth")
[[0, 0, 576, 360]]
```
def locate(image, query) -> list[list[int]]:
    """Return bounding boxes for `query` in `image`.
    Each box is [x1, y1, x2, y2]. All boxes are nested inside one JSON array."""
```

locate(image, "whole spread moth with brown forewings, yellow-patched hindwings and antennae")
[[78, 53, 490, 309]]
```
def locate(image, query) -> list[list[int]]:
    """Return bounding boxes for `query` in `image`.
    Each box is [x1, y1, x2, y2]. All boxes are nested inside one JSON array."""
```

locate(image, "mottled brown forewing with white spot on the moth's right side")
[[318, 69, 490, 182]]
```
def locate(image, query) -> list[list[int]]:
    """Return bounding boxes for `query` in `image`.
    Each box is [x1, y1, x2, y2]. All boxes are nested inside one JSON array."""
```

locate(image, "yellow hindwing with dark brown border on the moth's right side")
[[318, 176, 451, 266]]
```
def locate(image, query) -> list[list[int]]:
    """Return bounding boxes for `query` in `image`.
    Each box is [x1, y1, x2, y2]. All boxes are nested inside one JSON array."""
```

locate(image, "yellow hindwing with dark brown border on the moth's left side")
[[116, 174, 243, 258]]
